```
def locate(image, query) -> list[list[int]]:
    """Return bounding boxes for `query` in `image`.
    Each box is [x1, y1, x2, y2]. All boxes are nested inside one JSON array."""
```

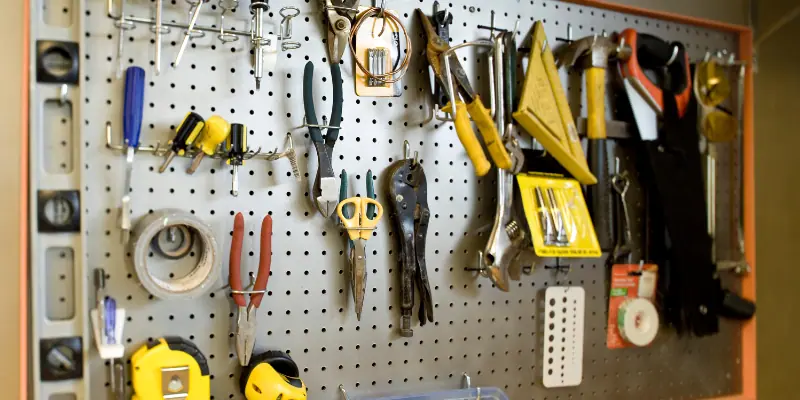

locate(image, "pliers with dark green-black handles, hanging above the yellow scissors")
[[303, 61, 343, 218]]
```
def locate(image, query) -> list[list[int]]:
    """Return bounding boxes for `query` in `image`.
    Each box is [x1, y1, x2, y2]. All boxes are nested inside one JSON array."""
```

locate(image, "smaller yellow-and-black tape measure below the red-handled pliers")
[[239, 351, 308, 400]]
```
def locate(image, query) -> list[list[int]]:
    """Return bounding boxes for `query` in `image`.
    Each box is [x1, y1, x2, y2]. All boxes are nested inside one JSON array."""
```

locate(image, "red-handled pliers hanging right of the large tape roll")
[[229, 213, 272, 366]]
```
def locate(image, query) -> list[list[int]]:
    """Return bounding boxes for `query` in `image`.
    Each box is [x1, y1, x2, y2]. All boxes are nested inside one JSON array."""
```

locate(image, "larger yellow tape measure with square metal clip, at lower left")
[[131, 336, 211, 400]]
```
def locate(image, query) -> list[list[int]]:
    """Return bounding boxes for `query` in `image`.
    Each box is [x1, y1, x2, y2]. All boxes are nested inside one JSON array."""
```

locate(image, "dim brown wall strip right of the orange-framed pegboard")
[[755, 0, 800, 399]]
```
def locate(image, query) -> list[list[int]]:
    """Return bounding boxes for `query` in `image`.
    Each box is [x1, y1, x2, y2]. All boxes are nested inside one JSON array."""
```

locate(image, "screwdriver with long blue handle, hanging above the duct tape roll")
[[119, 67, 144, 244]]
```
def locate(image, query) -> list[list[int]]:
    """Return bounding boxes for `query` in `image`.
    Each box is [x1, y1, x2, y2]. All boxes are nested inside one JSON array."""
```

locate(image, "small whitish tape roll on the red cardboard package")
[[617, 298, 659, 347]]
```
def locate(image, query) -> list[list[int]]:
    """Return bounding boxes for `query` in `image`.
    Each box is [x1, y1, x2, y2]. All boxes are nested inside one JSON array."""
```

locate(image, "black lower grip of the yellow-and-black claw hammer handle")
[[587, 139, 612, 251]]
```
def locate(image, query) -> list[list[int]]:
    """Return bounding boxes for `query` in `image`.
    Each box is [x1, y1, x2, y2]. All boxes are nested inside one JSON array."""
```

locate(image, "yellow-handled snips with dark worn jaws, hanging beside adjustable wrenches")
[[416, 8, 512, 176]]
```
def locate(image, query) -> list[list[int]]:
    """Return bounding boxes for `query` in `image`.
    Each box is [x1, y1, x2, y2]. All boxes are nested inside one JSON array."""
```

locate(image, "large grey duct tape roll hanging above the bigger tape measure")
[[131, 209, 222, 299]]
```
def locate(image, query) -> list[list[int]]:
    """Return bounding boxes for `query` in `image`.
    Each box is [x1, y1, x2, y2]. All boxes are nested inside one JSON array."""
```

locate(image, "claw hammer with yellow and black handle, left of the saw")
[[558, 35, 618, 251]]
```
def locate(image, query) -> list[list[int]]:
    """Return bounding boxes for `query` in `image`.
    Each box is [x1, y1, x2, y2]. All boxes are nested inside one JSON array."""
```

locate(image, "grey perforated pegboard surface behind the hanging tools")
[[31, 0, 741, 400]]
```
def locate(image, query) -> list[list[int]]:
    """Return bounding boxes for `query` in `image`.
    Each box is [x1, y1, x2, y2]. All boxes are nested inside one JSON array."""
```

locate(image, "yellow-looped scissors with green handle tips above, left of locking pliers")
[[336, 170, 383, 321]]
